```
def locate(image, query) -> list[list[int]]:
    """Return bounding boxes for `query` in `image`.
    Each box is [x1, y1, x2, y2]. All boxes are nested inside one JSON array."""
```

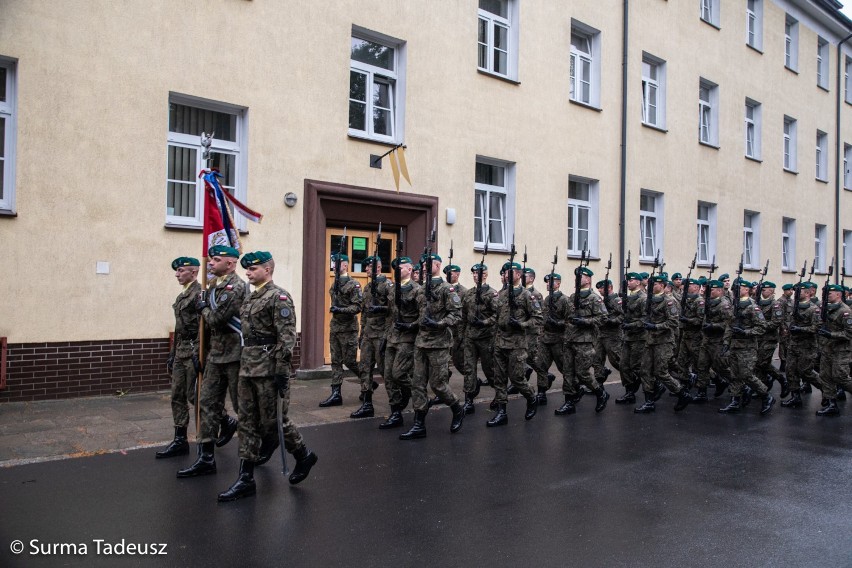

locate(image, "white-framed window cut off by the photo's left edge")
[[0, 56, 18, 213]]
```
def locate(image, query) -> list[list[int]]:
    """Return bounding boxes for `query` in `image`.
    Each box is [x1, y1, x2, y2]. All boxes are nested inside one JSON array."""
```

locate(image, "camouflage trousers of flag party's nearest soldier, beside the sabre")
[[238, 377, 304, 461]]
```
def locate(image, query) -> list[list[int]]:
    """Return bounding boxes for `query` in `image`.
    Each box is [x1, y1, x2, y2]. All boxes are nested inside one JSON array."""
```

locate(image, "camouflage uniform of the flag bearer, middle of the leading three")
[[199, 274, 248, 443]]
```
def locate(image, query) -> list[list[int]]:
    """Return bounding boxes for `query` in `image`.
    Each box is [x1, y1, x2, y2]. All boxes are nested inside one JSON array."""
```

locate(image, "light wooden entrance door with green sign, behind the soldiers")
[[323, 227, 397, 365]]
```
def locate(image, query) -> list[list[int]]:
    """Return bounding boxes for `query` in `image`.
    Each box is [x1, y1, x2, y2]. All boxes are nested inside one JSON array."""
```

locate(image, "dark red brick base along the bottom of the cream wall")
[[0, 337, 301, 403]]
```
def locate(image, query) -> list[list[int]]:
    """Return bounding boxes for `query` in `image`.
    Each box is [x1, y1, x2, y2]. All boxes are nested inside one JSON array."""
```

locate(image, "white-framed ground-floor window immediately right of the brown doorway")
[[473, 156, 515, 251]]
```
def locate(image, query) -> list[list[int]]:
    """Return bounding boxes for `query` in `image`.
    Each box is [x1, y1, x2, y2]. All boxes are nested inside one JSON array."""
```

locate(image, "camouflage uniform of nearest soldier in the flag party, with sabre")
[[239, 280, 304, 462]]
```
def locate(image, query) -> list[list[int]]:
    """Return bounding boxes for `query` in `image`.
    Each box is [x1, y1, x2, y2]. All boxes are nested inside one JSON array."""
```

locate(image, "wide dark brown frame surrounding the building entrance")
[[300, 179, 438, 369]]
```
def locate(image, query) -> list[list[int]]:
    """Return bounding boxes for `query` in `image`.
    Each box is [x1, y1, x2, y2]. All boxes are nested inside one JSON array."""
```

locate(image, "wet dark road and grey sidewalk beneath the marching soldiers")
[[0, 370, 852, 568]]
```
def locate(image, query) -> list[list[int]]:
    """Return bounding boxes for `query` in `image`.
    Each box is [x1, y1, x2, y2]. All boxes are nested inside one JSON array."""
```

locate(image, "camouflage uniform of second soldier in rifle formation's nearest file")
[[494, 287, 541, 404]]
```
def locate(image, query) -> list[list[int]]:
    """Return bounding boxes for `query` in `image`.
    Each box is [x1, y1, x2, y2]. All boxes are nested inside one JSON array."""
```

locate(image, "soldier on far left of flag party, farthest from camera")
[[156, 256, 201, 459]]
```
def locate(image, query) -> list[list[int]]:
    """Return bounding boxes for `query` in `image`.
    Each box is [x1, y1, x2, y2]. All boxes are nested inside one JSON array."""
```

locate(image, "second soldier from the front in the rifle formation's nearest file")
[[486, 262, 541, 426]]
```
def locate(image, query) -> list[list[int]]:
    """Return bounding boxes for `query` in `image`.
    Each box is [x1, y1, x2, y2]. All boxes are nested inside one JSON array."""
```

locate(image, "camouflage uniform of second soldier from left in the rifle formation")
[[361, 274, 393, 392]]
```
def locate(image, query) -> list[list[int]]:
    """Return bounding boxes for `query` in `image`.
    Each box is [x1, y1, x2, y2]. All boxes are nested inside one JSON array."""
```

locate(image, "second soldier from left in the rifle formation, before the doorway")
[[349, 256, 393, 418]]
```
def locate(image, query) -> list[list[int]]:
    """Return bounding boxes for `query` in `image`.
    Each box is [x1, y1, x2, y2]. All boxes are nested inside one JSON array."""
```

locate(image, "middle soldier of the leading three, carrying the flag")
[[177, 245, 248, 477]]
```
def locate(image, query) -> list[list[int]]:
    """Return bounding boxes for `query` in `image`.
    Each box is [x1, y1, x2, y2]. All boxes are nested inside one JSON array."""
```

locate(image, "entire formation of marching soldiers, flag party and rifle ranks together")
[[156, 227, 852, 501]]
